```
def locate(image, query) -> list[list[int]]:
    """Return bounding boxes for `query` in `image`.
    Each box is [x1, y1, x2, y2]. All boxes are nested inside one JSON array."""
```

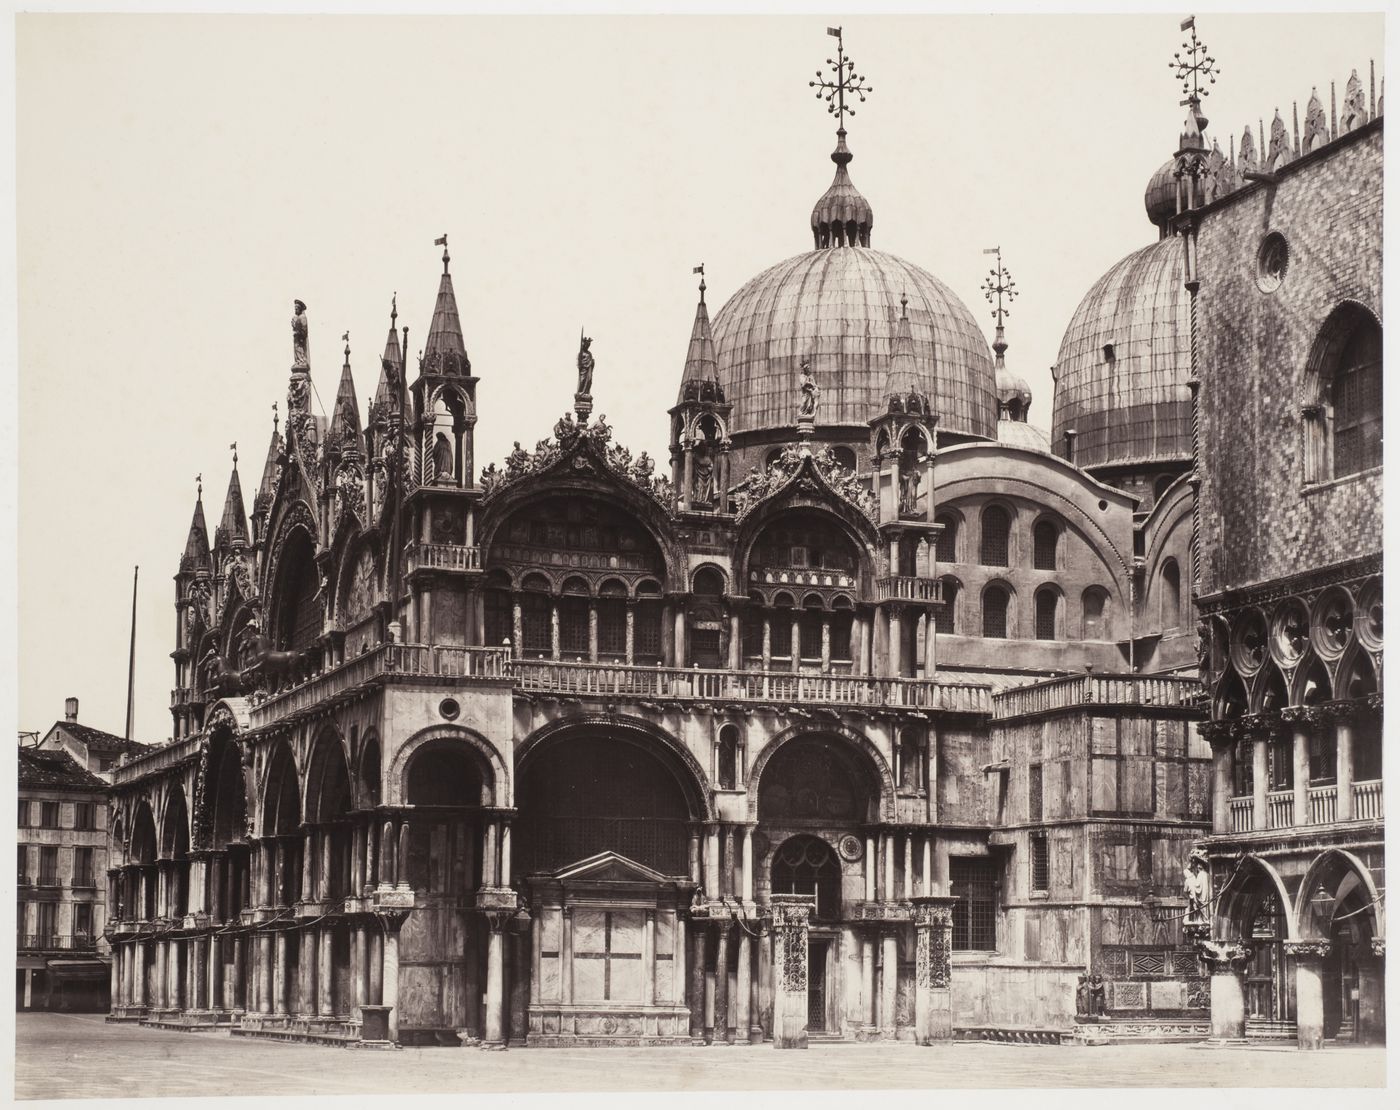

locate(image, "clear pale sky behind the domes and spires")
[[15, 11, 1383, 740]]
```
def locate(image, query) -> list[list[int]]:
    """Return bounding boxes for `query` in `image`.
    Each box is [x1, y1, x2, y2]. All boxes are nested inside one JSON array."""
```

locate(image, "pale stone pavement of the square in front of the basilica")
[[15, 1013, 1385, 1099]]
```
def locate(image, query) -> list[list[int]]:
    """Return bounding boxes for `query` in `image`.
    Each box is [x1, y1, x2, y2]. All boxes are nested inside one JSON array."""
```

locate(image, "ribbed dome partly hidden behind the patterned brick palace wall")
[[1050, 237, 1191, 466]]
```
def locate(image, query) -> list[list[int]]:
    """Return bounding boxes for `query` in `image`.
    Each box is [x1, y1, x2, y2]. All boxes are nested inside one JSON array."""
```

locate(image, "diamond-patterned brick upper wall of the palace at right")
[[1198, 129, 1383, 595]]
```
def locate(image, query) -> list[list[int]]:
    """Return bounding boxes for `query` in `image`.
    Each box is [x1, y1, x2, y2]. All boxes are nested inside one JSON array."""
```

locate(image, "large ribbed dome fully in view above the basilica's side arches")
[[713, 245, 997, 438]]
